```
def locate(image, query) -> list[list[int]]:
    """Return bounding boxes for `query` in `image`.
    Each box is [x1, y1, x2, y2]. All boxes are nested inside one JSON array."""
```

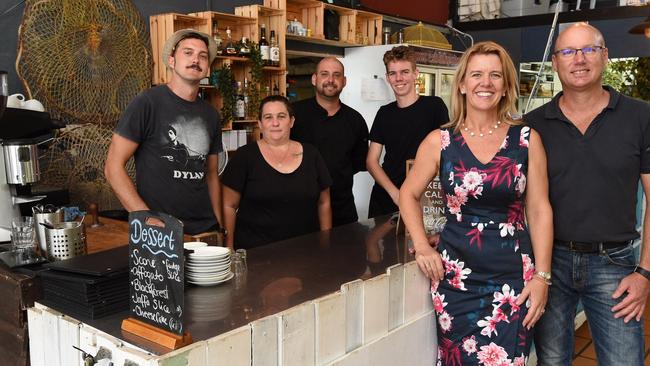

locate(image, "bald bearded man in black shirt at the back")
[[291, 57, 368, 226]]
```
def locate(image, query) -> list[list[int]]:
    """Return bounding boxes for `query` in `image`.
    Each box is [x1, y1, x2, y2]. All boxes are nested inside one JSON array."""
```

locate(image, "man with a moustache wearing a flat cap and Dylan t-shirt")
[[104, 29, 222, 235]]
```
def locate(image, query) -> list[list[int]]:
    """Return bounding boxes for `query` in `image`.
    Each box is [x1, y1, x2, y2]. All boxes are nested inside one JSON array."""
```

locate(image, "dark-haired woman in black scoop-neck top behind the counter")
[[221, 95, 332, 248]]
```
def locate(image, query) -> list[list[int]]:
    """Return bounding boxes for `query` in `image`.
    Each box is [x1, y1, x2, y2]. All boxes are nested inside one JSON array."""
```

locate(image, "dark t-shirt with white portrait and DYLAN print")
[[115, 85, 222, 234]]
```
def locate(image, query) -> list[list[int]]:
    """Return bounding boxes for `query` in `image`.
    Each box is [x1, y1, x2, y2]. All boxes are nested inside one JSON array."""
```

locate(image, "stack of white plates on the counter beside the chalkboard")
[[184, 242, 233, 286]]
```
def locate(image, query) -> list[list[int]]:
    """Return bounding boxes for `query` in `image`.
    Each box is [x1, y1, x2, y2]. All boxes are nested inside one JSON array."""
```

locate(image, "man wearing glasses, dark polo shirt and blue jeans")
[[525, 23, 650, 366]]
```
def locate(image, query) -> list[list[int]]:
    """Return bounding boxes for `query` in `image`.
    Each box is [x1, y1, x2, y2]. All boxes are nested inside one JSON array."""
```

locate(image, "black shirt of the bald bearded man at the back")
[[291, 98, 368, 226]]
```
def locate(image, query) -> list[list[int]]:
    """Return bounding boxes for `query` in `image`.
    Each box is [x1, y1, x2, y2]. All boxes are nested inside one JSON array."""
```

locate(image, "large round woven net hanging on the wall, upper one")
[[16, 0, 152, 126]]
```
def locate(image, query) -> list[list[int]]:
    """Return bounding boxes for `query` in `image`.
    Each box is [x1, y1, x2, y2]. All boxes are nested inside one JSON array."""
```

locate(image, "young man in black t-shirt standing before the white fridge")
[[366, 46, 449, 217]]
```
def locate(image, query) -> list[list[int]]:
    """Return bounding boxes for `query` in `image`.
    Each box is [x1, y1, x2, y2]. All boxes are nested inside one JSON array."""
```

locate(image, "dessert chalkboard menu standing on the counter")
[[129, 211, 184, 335]]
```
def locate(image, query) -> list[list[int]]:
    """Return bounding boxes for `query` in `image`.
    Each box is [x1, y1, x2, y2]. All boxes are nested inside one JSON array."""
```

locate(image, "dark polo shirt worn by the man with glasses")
[[524, 87, 650, 242]]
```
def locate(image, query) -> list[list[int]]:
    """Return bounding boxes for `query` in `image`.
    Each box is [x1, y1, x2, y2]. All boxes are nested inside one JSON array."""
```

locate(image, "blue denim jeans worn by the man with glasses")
[[534, 245, 643, 366]]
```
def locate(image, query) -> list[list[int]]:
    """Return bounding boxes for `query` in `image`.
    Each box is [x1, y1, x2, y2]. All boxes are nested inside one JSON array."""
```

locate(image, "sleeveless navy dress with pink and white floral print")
[[431, 125, 535, 366]]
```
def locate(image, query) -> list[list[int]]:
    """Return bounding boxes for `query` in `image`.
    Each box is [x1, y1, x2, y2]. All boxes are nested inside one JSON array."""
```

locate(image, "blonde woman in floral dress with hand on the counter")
[[399, 42, 553, 366]]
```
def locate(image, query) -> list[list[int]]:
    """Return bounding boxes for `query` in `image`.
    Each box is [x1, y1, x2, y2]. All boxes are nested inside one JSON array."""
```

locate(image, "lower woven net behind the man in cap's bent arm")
[[42, 123, 135, 210]]
